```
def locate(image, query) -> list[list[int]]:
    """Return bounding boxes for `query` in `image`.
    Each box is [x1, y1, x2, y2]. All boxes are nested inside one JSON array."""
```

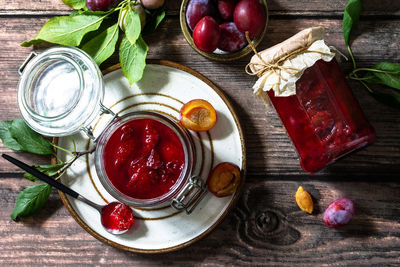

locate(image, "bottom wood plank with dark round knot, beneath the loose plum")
[[0, 178, 400, 266]]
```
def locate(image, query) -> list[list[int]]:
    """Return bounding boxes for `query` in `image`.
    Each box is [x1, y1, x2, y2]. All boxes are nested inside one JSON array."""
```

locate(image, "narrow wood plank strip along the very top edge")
[[0, 0, 400, 17]]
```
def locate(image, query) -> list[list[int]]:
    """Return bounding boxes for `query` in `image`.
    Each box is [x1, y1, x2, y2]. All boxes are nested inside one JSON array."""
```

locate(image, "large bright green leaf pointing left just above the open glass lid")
[[21, 14, 106, 46]]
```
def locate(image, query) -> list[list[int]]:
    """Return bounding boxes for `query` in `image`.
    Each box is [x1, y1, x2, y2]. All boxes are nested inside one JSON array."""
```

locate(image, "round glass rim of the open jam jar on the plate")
[[94, 111, 195, 208]]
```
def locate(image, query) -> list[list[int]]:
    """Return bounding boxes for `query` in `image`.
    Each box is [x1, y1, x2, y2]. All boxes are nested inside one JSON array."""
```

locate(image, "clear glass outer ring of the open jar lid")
[[17, 45, 104, 137]]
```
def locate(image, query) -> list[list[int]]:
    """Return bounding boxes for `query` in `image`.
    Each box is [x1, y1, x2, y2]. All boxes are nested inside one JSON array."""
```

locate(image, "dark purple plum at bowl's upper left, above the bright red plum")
[[186, 0, 217, 31]]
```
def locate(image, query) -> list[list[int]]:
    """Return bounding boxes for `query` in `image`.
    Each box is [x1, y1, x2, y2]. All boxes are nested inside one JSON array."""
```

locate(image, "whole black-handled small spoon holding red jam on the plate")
[[2, 154, 134, 235]]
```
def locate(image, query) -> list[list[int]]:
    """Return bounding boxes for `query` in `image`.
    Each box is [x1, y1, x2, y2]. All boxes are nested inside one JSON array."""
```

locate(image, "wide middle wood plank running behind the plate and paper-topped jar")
[[0, 18, 400, 179]]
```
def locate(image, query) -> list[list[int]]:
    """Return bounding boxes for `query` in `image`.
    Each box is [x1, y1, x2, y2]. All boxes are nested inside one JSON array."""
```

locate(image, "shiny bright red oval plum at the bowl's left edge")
[[193, 16, 221, 53]]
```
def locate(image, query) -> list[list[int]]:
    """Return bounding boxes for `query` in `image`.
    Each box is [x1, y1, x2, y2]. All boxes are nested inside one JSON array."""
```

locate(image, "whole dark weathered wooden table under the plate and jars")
[[0, 0, 400, 266]]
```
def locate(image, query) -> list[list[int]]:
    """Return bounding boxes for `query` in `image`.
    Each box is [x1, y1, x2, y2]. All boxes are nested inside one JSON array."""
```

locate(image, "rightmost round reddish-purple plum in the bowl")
[[233, 0, 266, 38]]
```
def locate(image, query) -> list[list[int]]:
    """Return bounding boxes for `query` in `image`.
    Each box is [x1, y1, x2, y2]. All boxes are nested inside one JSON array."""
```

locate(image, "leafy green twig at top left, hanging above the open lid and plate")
[[21, 0, 165, 84]]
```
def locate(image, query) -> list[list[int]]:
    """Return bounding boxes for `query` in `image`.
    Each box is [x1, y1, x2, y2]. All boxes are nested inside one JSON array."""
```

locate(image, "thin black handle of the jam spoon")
[[2, 154, 79, 198]]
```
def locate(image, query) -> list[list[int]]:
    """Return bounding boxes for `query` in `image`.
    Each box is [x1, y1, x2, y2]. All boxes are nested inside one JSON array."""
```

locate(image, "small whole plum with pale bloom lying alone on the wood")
[[324, 197, 354, 228]]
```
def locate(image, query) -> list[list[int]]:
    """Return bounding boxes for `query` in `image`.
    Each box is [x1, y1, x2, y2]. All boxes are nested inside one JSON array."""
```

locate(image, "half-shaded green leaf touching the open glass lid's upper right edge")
[[82, 24, 119, 65]]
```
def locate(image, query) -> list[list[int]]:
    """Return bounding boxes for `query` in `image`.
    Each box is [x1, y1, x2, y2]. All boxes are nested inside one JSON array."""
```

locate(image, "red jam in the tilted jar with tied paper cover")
[[267, 59, 375, 173]]
